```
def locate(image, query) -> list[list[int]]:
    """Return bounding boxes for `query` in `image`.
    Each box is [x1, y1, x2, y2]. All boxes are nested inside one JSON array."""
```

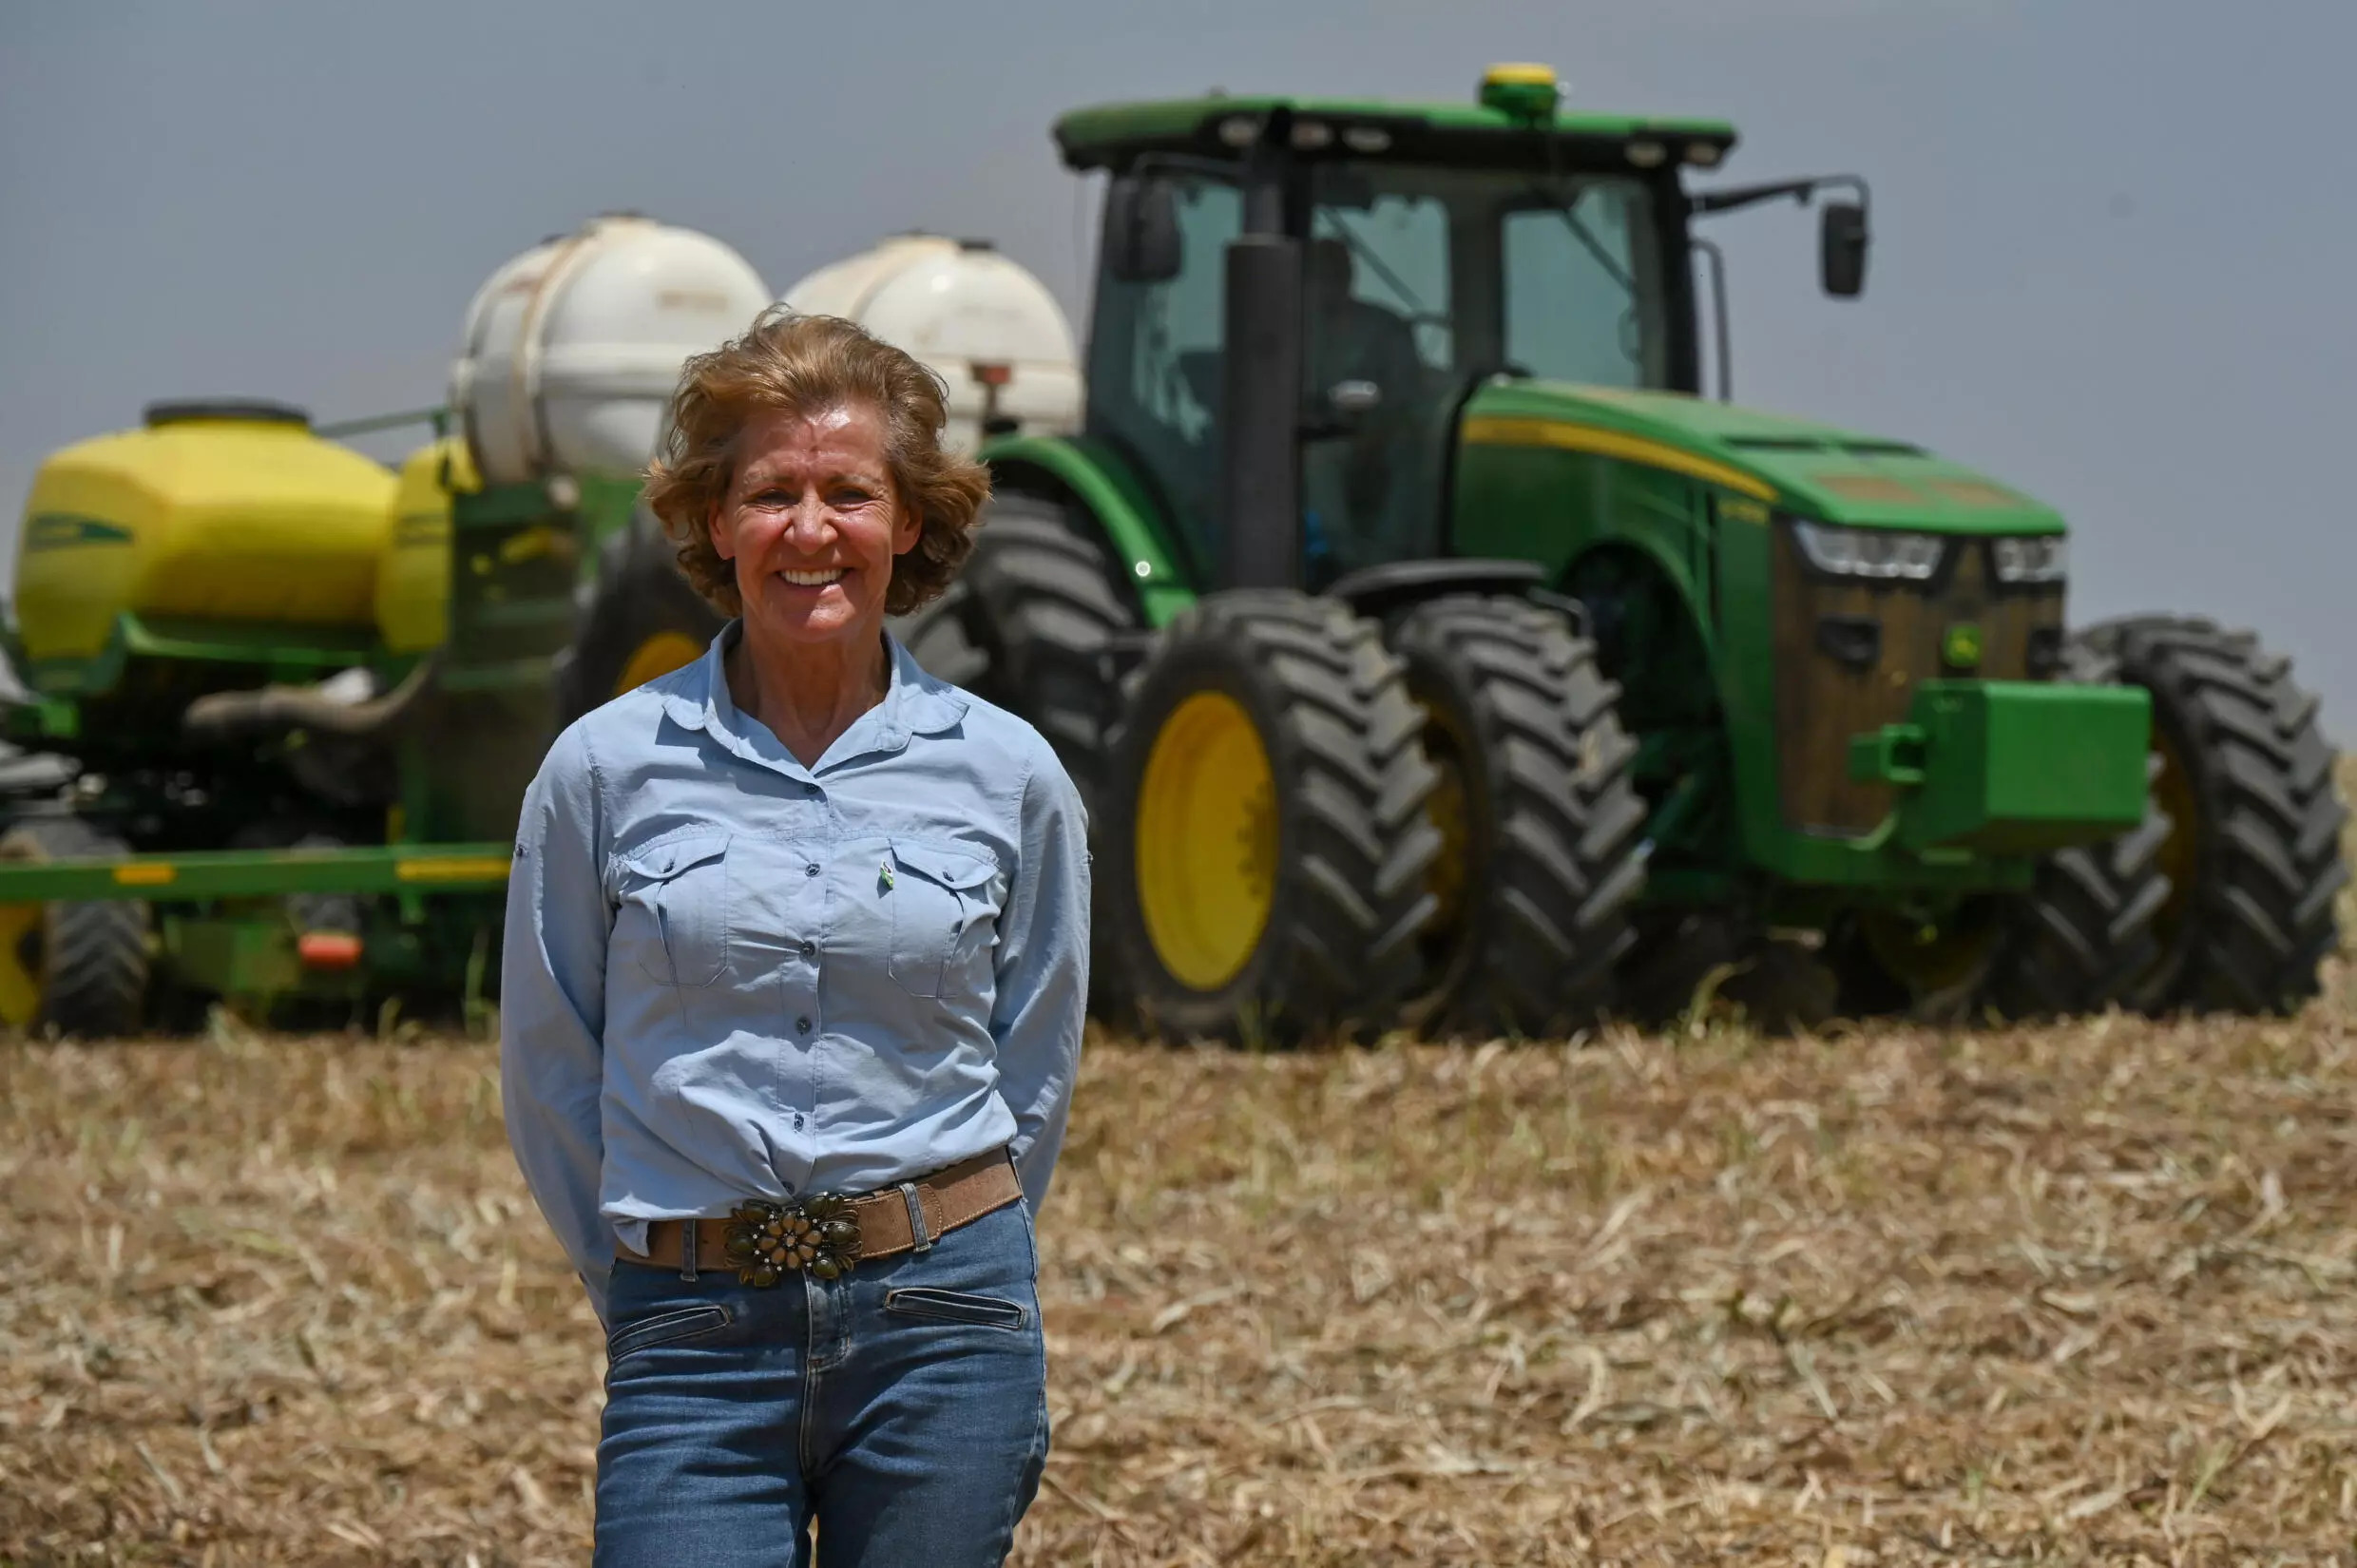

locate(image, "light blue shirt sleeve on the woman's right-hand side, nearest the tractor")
[[990, 743, 1091, 1214]]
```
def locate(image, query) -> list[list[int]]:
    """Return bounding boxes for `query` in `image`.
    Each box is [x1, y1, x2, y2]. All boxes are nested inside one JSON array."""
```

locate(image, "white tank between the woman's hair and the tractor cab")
[[785, 234, 1082, 452]]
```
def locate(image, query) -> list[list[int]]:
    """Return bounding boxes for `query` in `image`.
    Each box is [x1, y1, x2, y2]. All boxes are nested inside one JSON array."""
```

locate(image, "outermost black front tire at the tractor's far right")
[[2083, 616, 2350, 1014]]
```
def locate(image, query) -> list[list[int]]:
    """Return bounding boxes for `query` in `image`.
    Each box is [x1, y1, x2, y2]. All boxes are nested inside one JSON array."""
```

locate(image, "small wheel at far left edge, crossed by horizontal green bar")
[[0, 815, 148, 1040]]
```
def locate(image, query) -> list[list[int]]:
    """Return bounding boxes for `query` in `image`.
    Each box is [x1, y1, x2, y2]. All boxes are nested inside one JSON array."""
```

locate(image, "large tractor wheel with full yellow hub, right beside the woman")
[[1099, 589, 1440, 1042]]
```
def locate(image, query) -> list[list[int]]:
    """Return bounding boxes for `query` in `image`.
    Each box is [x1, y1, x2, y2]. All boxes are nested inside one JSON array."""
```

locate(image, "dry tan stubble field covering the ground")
[[0, 796, 2357, 1568]]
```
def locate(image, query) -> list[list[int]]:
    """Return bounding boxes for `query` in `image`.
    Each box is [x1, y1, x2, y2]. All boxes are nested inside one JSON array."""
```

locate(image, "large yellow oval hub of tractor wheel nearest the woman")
[[1136, 691, 1277, 990]]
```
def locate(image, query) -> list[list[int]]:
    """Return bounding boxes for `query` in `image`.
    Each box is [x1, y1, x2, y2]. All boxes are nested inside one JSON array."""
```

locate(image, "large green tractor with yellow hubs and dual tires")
[[872, 66, 2347, 1035]]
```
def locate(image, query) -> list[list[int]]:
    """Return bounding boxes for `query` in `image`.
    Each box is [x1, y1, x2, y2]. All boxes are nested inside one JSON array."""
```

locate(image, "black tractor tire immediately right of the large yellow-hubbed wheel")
[[1390, 594, 1645, 1038]]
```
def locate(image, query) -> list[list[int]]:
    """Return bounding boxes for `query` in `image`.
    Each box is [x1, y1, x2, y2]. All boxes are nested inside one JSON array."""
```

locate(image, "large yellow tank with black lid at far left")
[[16, 403, 396, 662]]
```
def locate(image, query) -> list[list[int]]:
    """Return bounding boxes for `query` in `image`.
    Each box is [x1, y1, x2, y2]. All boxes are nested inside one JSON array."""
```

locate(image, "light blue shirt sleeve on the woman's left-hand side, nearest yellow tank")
[[500, 726, 613, 1323]]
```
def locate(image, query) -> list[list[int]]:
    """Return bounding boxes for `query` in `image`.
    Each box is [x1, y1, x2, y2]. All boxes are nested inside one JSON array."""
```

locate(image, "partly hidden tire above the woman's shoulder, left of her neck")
[[556, 511, 726, 724]]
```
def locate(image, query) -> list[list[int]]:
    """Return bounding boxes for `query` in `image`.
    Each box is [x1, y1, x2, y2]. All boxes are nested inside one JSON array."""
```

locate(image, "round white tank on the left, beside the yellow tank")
[[450, 215, 773, 484]]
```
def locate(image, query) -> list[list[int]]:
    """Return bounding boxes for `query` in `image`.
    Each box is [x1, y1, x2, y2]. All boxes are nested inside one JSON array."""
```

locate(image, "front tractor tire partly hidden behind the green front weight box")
[[1980, 637, 2171, 1021]]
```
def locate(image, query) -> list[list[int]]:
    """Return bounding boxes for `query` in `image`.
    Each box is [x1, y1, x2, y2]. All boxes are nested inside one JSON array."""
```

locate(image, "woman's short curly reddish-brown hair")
[[646, 304, 990, 616]]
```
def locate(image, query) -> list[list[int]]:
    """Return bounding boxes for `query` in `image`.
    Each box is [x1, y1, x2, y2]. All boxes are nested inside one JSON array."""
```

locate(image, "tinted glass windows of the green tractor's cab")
[[1089, 161, 1674, 587]]
